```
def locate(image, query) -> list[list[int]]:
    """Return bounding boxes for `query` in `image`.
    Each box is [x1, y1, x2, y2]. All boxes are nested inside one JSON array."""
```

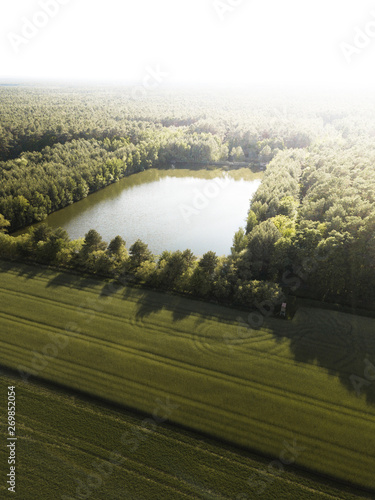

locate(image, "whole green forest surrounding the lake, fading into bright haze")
[[0, 86, 375, 308]]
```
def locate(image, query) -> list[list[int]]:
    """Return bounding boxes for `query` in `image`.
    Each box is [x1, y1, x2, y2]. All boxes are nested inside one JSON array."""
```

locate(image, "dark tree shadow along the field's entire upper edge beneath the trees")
[[0, 261, 375, 405]]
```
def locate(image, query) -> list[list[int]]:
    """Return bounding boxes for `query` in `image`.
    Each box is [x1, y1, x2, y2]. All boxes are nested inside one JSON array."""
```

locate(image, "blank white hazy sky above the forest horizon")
[[0, 0, 375, 86]]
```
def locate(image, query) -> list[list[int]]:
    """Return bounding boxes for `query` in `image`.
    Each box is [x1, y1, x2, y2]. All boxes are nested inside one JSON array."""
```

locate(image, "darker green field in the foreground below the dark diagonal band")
[[0, 372, 370, 500]]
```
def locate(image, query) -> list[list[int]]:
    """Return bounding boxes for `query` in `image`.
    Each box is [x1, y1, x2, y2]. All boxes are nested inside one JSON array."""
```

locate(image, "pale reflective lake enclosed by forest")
[[26, 168, 263, 256]]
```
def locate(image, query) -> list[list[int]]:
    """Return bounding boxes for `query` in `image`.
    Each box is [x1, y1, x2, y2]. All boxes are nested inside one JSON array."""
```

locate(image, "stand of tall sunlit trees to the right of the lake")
[[243, 142, 375, 306]]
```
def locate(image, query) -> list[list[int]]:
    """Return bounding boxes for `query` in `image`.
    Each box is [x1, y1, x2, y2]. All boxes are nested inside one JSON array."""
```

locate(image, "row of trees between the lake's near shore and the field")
[[0, 223, 282, 307]]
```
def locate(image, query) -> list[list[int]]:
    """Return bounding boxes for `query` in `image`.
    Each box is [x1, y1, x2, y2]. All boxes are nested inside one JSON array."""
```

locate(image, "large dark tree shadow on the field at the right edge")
[[275, 308, 375, 404]]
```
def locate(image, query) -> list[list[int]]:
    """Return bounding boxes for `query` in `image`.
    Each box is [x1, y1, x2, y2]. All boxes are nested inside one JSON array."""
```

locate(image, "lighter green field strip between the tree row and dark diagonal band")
[[0, 264, 375, 498]]
